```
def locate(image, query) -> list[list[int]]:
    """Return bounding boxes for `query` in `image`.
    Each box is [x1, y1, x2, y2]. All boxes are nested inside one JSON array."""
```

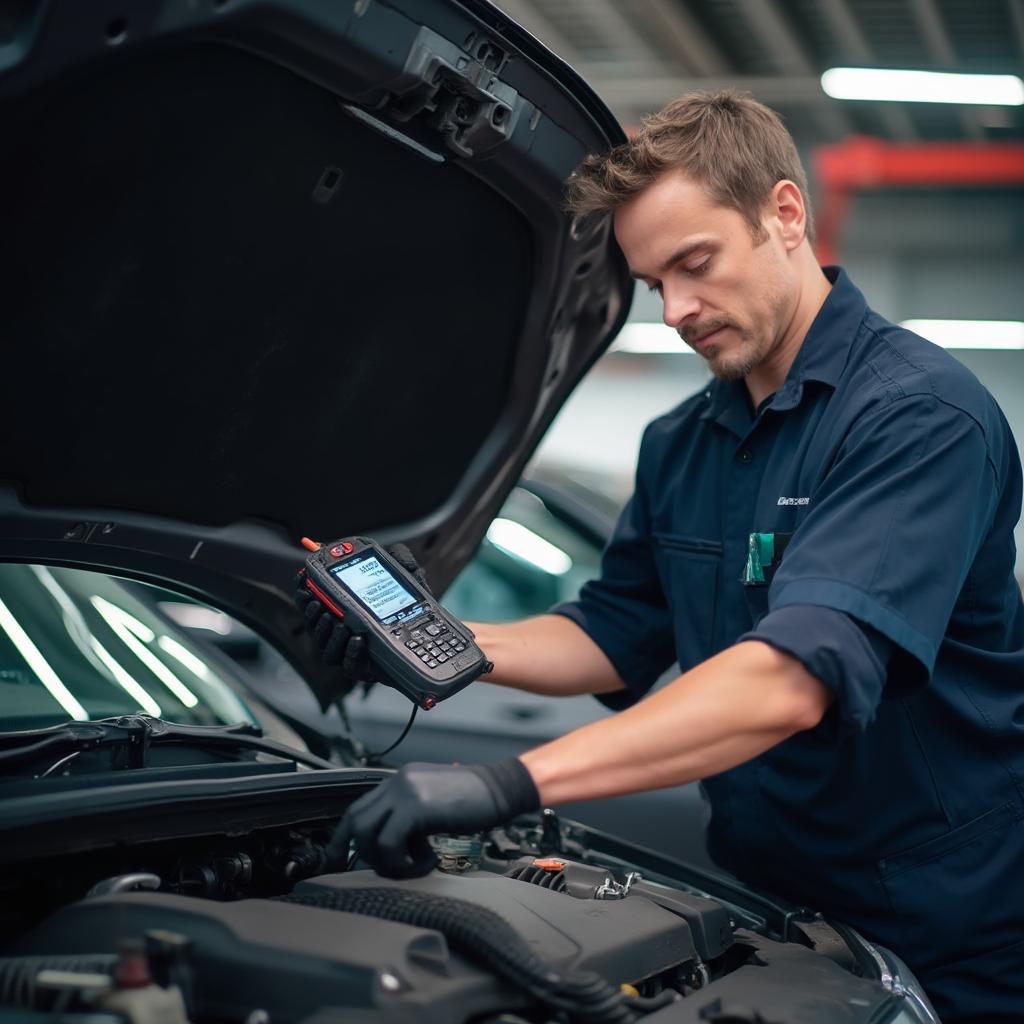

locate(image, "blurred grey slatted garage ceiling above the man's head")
[[487, 0, 1024, 144]]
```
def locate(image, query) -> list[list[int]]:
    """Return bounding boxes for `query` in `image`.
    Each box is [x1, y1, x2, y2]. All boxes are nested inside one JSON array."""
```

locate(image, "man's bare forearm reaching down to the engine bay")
[[520, 641, 831, 804]]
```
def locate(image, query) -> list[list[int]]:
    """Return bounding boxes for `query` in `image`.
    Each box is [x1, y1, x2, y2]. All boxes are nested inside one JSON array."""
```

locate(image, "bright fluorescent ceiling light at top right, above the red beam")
[[821, 68, 1024, 106]]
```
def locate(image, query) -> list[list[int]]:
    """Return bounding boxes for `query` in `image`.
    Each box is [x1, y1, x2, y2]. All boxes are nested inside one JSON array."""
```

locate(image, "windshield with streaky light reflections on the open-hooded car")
[[0, 564, 256, 731]]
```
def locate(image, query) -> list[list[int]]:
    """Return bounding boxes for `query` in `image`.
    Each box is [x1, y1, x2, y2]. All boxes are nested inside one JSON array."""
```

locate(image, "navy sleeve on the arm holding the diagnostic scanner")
[[551, 454, 676, 711]]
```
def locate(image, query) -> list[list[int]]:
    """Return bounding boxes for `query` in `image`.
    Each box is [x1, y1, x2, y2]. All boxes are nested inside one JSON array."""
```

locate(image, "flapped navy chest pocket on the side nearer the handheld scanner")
[[654, 532, 722, 672]]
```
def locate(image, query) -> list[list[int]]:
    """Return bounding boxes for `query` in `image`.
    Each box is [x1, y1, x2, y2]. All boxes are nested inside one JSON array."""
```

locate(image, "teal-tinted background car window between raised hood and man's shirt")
[[443, 487, 601, 622]]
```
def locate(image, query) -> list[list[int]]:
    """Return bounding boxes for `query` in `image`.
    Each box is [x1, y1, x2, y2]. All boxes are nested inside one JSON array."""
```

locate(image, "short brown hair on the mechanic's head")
[[566, 91, 814, 243]]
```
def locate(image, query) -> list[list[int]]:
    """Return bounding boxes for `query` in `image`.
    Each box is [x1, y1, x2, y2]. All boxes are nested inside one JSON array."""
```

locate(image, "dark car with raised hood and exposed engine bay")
[[0, 0, 934, 1024]]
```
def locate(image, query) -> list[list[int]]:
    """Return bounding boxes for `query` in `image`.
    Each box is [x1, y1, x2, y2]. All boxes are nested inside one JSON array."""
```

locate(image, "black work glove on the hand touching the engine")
[[327, 758, 541, 879]]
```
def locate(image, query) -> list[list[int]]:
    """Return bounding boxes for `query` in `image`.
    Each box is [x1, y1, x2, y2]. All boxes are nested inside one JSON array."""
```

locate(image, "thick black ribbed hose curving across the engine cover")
[[275, 888, 653, 1024]]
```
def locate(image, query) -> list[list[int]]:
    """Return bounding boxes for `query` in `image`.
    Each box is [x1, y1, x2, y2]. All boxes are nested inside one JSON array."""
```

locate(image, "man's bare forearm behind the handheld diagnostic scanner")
[[467, 615, 624, 697]]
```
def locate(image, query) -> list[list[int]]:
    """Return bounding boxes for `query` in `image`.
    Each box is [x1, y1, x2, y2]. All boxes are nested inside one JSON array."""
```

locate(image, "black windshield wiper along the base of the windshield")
[[0, 715, 338, 774]]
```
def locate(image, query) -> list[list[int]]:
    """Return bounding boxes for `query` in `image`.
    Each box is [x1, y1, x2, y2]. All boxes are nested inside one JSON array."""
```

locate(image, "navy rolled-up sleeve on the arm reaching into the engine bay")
[[748, 395, 998, 728]]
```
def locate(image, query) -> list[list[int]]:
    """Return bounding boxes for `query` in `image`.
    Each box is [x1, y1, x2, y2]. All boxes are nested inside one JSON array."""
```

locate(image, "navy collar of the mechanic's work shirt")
[[701, 266, 867, 432]]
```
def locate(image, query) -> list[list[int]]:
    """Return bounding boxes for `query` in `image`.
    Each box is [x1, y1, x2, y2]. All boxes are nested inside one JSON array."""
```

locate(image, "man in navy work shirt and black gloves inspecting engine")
[[308, 93, 1024, 1022]]
